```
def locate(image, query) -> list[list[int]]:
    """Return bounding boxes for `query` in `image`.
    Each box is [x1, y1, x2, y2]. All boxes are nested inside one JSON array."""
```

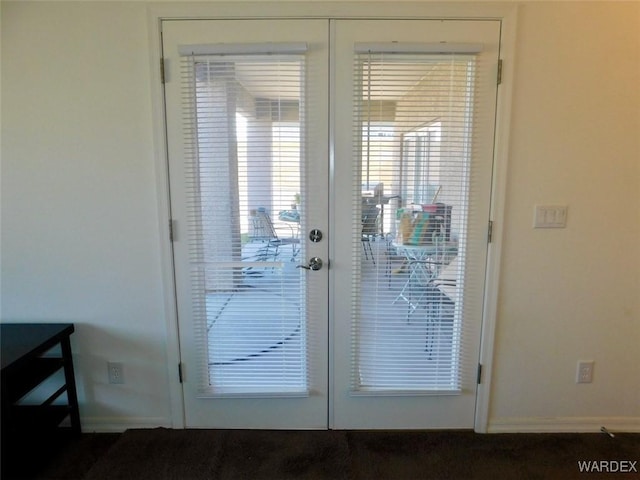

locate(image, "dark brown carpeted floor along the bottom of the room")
[[4, 428, 640, 480]]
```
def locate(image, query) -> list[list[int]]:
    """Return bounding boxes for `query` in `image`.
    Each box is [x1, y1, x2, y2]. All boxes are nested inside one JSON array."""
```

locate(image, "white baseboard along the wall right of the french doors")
[[487, 417, 640, 433]]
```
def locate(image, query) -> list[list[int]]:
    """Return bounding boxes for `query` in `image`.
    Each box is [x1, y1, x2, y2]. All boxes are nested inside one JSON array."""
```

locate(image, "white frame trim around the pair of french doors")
[[147, 1, 517, 433]]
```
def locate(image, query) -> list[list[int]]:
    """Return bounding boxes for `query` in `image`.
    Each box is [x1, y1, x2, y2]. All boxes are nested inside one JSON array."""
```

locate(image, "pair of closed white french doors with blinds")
[[162, 19, 500, 429]]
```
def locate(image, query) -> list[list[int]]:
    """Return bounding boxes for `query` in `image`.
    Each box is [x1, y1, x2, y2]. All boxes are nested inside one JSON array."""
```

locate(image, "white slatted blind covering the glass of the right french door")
[[351, 48, 486, 394]]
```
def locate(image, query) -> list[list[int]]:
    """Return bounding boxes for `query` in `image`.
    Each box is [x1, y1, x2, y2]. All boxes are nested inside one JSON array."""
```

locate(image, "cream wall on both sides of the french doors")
[[0, 1, 640, 431]]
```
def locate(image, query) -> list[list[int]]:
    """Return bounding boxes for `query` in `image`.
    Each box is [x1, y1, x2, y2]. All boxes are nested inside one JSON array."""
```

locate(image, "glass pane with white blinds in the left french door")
[[183, 54, 307, 396]]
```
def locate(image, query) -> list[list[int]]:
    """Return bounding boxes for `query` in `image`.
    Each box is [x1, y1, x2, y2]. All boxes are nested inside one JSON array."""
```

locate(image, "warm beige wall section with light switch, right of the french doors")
[[490, 2, 640, 428]]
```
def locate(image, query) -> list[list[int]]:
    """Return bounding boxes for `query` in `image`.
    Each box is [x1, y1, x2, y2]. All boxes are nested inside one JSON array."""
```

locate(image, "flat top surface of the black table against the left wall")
[[0, 323, 74, 370]]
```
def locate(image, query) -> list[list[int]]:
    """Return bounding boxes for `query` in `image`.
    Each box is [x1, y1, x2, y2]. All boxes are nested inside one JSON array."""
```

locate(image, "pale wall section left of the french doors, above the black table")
[[1, 2, 170, 429]]
